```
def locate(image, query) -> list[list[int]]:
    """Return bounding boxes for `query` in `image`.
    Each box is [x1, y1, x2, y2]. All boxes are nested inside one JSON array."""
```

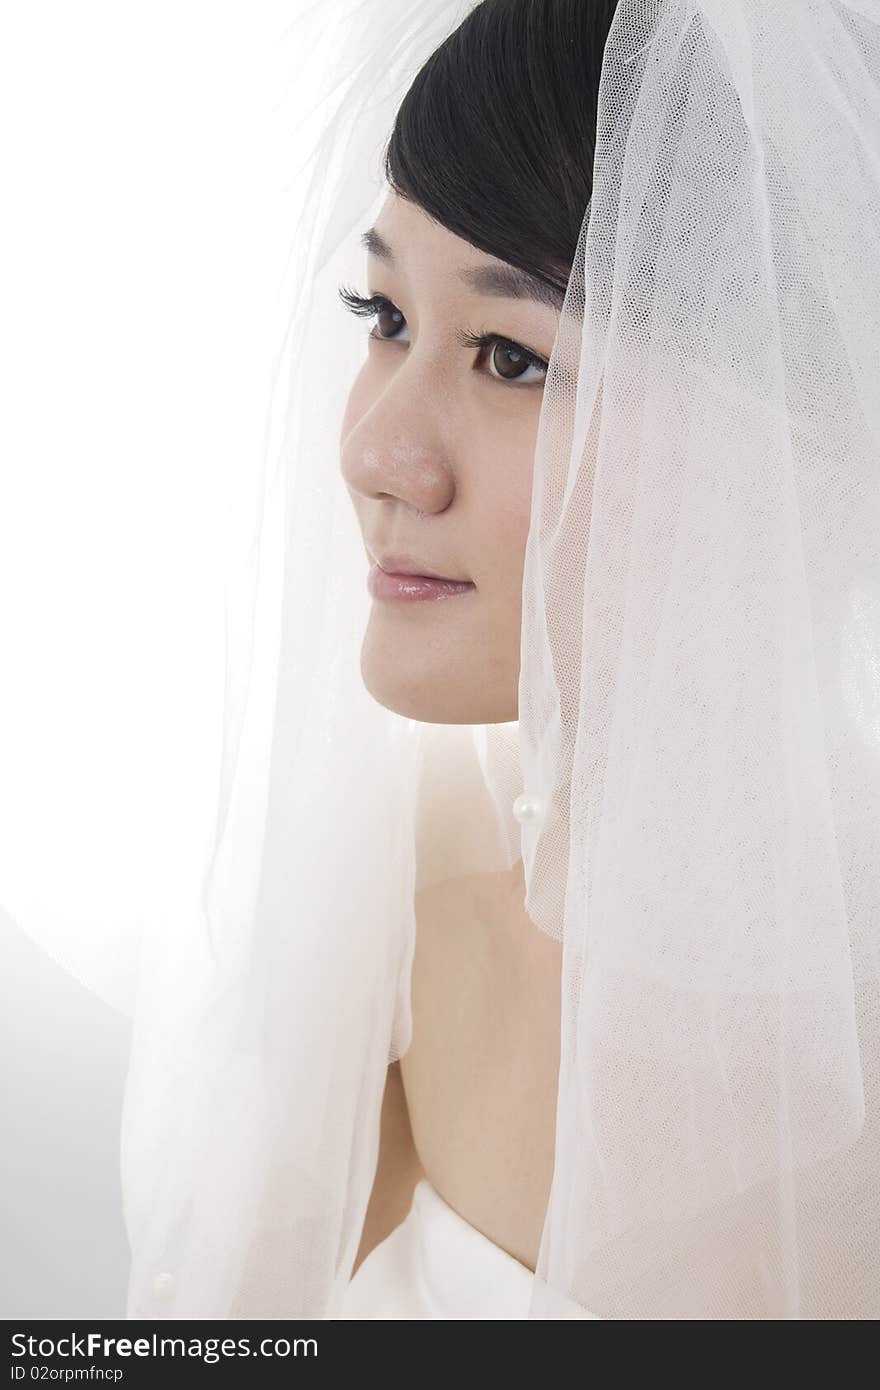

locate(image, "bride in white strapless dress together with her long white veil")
[[22, 0, 880, 1321]]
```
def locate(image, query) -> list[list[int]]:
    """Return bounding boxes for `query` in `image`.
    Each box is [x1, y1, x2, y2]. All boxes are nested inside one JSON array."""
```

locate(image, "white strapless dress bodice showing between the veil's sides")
[[336, 1177, 596, 1321]]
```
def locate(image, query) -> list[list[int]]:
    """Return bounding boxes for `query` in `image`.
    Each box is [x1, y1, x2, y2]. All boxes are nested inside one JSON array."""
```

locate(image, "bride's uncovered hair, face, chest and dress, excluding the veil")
[[332, 3, 614, 1318]]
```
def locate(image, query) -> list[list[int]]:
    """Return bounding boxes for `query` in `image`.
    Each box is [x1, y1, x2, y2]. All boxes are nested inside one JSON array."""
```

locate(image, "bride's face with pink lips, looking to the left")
[[341, 193, 560, 724]]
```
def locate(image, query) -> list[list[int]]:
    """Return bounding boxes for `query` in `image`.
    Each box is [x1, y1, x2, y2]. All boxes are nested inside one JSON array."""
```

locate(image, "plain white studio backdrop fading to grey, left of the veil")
[[0, 0, 315, 1318]]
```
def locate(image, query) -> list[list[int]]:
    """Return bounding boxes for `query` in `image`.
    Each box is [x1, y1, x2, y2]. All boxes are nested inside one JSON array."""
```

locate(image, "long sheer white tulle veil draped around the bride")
[[0, 0, 880, 1319]]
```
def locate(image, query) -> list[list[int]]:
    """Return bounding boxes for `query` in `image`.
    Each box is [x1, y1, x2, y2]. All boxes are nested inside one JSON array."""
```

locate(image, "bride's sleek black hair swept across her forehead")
[[385, 0, 617, 291]]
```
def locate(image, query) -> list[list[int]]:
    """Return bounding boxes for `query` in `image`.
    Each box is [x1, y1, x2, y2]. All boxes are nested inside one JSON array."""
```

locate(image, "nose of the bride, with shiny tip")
[[339, 367, 455, 514]]
